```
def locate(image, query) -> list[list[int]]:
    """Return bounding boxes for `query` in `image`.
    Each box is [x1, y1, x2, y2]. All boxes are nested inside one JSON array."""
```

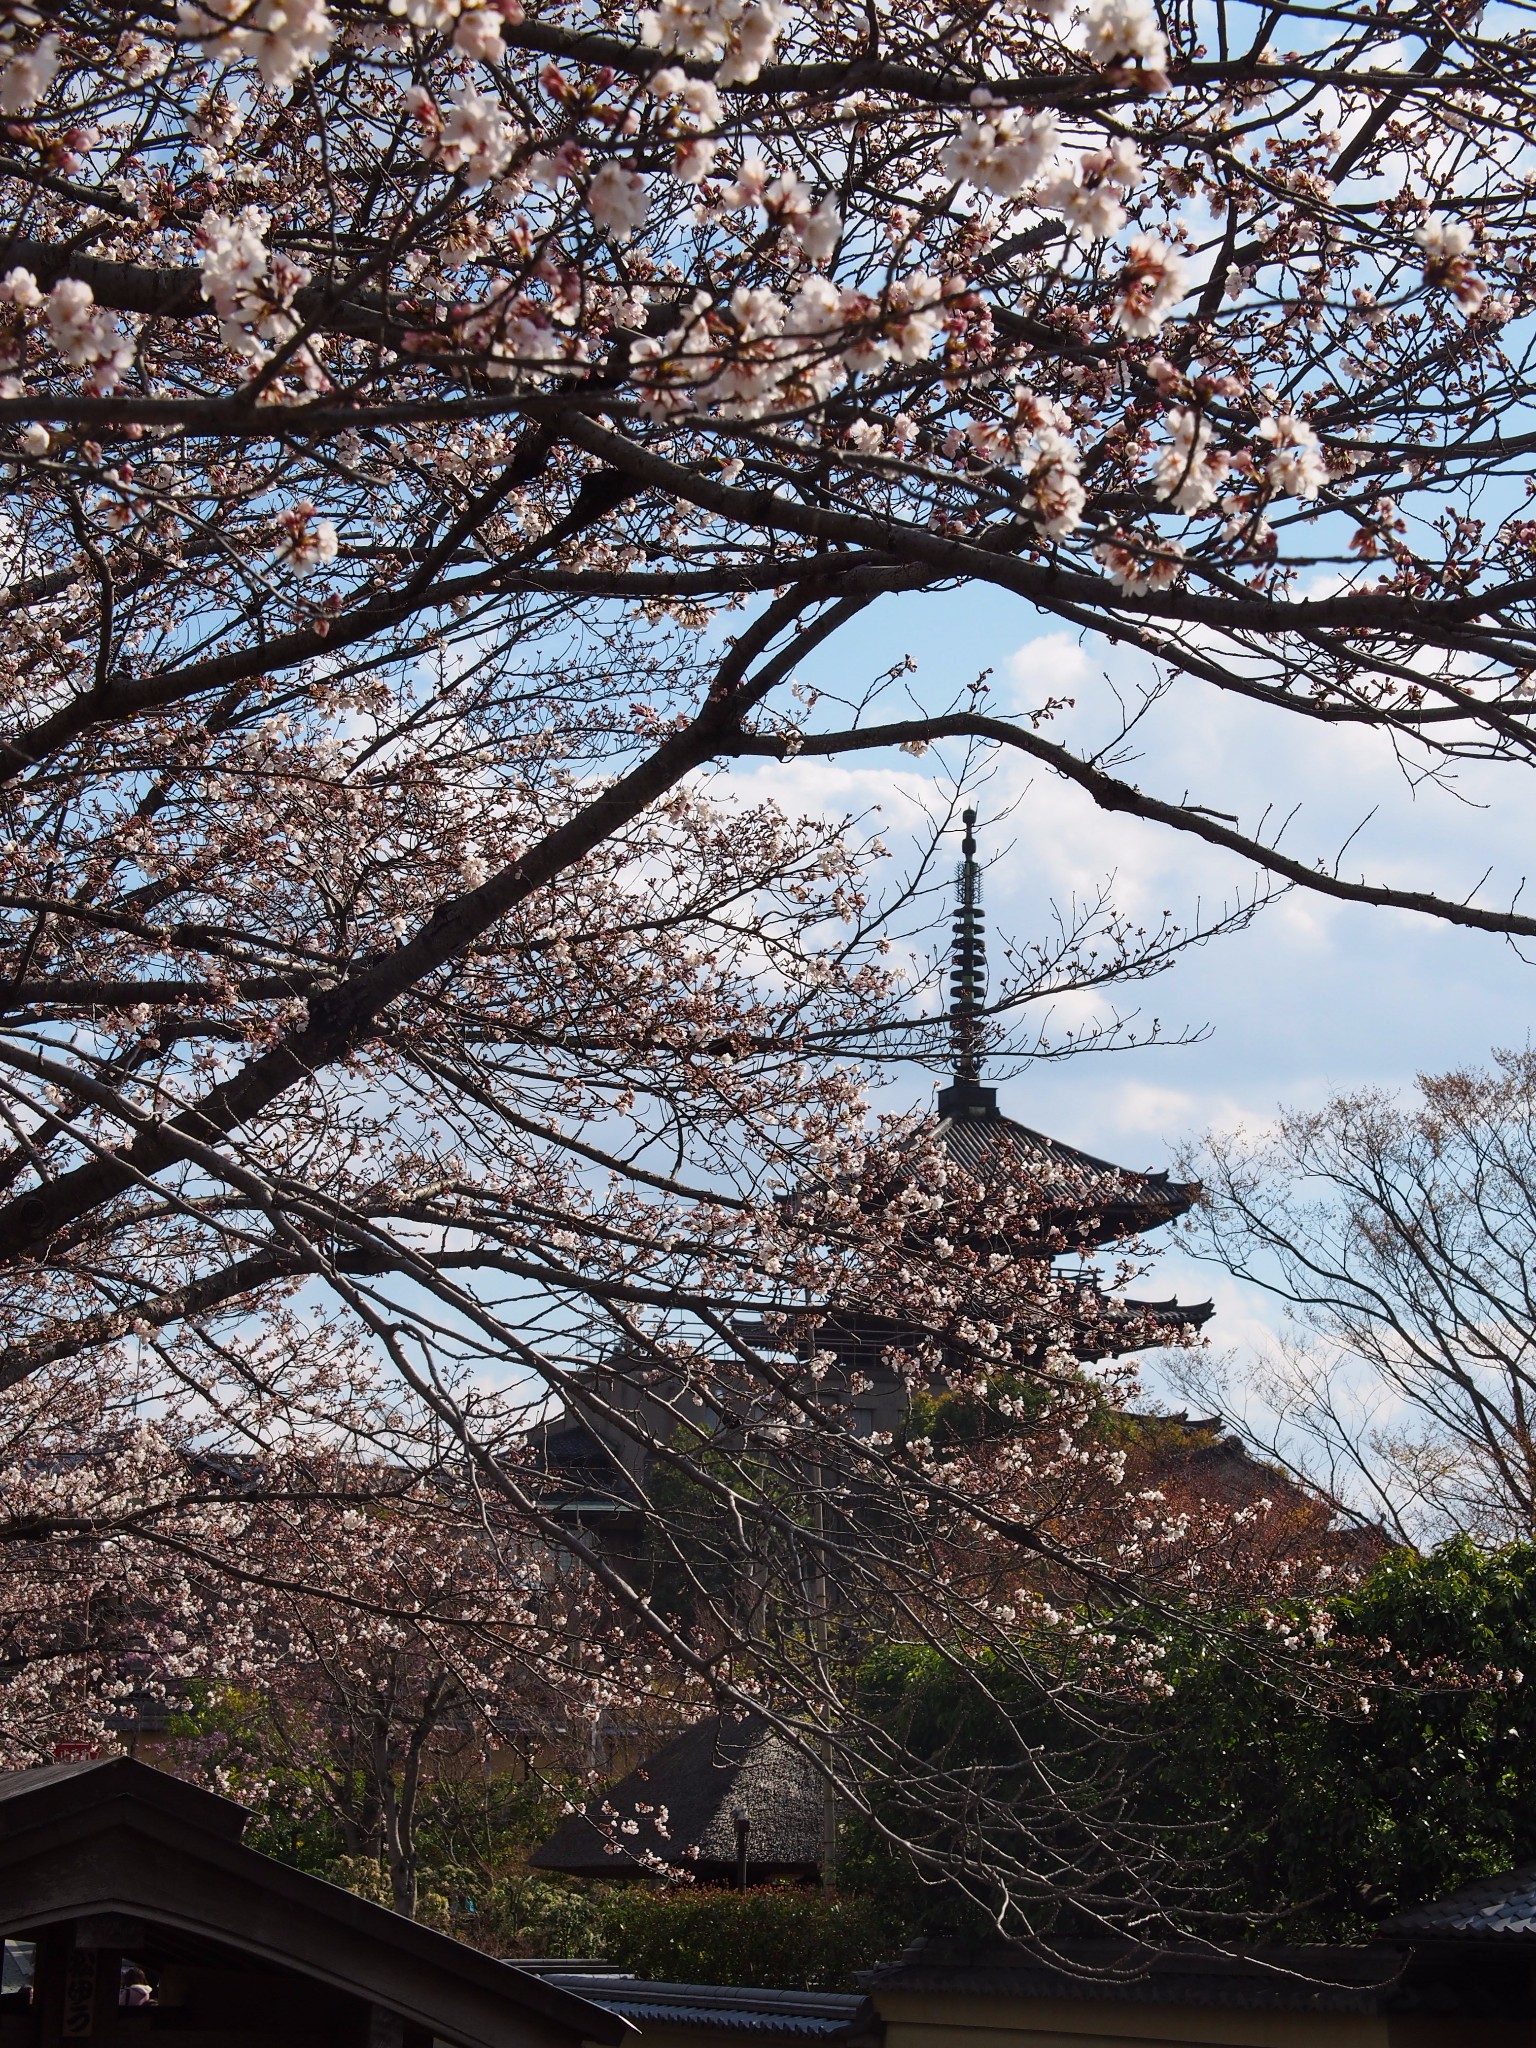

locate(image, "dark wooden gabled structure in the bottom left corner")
[[0, 1757, 635, 2048]]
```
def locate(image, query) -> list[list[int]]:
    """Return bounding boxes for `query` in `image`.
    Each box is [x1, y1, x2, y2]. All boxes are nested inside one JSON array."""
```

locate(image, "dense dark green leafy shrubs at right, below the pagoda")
[[844, 1538, 1536, 1939]]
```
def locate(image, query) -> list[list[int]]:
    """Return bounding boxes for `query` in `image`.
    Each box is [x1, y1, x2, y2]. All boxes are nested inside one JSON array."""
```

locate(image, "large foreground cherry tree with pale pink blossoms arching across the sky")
[[0, 0, 1536, 1915]]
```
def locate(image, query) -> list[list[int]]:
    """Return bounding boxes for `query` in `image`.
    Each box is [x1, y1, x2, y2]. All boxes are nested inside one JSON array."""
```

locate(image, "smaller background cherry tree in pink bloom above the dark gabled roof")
[[0, 1317, 623, 1913]]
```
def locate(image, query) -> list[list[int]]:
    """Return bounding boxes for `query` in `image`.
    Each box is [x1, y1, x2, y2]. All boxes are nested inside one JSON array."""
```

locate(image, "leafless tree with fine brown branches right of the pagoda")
[[1184, 1049, 1536, 1542]]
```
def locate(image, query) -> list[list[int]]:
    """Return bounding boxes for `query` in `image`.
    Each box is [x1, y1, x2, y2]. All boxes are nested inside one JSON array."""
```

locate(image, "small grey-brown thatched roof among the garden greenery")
[[530, 1714, 823, 1884]]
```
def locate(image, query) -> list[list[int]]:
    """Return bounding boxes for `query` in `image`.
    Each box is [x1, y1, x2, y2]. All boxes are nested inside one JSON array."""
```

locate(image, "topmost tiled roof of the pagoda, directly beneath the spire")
[[934, 1081, 1200, 1251]]
